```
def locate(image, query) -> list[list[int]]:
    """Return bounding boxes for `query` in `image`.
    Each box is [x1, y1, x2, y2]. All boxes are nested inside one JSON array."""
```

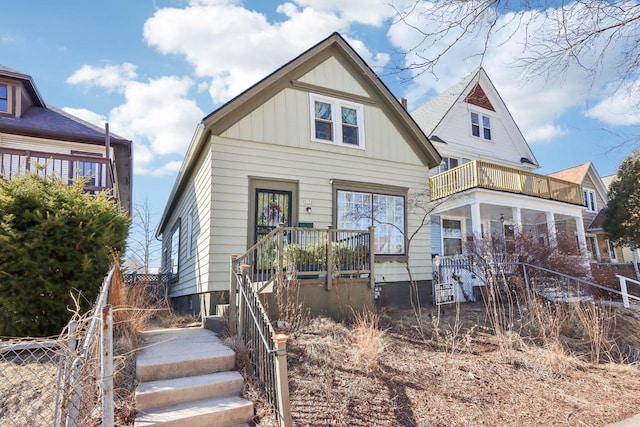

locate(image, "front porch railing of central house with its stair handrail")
[[228, 224, 375, 427]]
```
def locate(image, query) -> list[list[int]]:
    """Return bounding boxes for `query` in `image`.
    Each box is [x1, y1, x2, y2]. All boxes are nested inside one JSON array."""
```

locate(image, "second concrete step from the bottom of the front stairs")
[[136, 371, 244, 412]]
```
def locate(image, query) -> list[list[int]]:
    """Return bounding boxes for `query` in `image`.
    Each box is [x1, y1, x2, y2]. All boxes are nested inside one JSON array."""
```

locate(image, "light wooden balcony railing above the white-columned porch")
[[429, 160, 582, 205]]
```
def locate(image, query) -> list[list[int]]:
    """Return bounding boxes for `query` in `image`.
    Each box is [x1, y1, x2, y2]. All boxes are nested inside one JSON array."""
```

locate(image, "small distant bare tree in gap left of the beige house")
[[127, 199, 160, 273]]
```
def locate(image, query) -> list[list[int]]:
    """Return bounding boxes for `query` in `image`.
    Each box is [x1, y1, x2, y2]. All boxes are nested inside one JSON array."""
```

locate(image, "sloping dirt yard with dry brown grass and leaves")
[[251, 303, 640, 427]]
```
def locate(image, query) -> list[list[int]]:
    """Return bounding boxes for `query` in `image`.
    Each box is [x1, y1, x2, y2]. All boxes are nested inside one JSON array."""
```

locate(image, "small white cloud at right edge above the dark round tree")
[[585, 81, 640, 126]]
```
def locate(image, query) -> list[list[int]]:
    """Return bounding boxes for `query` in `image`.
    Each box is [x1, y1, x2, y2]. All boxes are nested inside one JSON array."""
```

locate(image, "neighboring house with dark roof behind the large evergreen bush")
[[0, 66, 132, 212]]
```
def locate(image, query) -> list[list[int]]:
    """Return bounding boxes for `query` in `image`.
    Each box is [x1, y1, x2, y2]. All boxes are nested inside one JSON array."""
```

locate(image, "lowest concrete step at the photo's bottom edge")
[[134, 396, 253, 427]]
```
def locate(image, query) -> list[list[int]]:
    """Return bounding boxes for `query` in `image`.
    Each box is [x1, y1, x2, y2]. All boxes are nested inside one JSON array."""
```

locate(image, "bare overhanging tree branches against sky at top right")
[[394, 0, 640, 86]]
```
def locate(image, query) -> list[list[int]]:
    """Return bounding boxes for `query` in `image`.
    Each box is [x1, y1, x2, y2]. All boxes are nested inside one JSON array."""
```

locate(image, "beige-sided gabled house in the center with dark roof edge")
[[157, 33, 441, 314]]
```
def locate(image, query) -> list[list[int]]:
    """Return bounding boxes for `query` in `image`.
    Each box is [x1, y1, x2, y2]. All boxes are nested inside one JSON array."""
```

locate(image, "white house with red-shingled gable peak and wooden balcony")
[[412, 68, 586, 300]]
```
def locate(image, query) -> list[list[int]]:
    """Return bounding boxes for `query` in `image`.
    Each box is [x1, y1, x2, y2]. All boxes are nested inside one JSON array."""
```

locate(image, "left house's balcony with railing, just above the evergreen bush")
[[0, 147, 116, 196]]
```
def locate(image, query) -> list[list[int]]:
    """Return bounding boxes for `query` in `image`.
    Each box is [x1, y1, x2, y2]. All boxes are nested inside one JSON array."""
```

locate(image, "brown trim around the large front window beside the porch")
[[332, 180, 409, 261]]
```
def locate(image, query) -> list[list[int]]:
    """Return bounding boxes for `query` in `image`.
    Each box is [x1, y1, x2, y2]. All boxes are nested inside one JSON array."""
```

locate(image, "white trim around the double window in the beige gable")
[[309, 93, 365, 150]]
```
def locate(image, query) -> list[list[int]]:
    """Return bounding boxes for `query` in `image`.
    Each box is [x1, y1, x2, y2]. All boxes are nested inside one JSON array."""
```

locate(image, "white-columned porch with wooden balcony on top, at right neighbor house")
[[429, 161, 587, 256]]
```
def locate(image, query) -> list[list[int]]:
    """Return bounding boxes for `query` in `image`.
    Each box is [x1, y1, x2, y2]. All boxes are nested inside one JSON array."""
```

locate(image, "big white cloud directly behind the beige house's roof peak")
[[144, 0, 391, 103]]
